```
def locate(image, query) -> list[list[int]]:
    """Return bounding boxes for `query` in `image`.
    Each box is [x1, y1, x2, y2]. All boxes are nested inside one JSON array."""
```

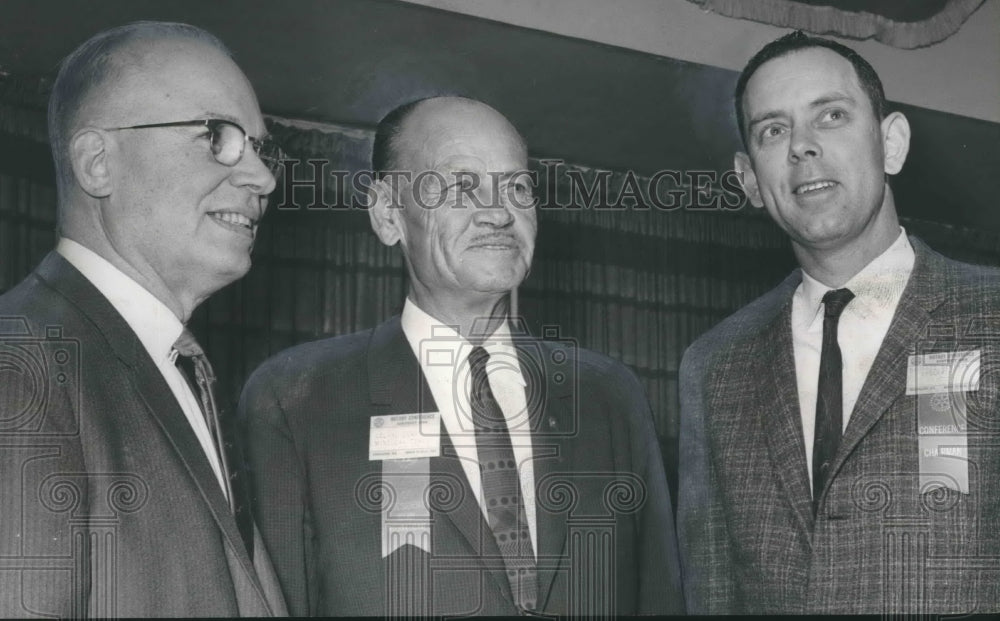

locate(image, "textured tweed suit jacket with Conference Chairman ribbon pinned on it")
[[678, 238, 1000, 613]]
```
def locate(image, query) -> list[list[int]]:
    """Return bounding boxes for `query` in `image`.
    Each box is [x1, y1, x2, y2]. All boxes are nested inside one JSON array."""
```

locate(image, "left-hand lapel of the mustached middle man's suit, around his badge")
[[368, 316, 513, 599]]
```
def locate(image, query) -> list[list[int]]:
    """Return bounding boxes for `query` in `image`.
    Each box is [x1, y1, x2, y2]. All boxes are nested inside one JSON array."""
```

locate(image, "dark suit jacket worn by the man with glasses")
[[0, 252, 286, 617]]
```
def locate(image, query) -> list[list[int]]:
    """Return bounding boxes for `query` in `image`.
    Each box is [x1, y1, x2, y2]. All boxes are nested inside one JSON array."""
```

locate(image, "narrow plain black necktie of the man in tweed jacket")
[[813, 289, 854, 515]]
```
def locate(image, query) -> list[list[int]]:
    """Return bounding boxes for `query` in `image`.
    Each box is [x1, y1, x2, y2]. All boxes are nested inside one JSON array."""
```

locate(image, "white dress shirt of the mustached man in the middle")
[[400, 298, 538, 557]]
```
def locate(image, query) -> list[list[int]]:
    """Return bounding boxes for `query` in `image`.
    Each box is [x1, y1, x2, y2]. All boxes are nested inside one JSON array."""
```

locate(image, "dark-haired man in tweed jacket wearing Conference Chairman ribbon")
[[678, 32, 1000, 614]]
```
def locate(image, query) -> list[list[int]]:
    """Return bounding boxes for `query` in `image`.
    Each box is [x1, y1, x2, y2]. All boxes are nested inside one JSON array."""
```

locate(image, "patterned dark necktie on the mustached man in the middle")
[[469, 347, 538, 610]]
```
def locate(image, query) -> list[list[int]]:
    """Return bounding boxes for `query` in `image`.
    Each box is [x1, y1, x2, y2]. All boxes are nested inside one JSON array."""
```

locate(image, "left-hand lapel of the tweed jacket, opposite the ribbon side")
[[752, 304, 813, 532]]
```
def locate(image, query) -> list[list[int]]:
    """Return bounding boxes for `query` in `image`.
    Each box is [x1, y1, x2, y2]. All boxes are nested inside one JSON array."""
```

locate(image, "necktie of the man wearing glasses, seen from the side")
[[174, 328, 253, 559]]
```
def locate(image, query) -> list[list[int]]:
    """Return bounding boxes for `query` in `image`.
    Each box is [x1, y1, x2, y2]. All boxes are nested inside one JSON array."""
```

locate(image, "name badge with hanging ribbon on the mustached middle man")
[[368, 412, 441, 558]]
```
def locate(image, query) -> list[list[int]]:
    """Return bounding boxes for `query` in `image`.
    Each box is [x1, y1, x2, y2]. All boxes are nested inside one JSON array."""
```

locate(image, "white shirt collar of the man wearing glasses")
[[56, 237, 184, 363]]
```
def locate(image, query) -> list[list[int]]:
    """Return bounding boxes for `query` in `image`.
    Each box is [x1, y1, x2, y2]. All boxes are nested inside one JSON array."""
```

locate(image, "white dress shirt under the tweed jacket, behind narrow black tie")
[[792, 230, 914, 487]]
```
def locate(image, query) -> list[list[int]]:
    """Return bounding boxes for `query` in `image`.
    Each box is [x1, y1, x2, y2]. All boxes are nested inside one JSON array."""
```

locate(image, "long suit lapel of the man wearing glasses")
[[37, 252, 266, 605]]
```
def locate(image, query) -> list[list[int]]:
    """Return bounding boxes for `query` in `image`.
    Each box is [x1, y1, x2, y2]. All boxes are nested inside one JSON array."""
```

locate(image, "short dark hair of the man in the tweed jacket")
[[733, 30, 886, 148]]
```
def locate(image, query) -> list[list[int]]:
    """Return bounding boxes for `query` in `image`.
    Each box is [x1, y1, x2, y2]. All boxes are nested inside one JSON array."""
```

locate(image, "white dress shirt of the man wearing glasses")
[[56, 238, 226, 495]]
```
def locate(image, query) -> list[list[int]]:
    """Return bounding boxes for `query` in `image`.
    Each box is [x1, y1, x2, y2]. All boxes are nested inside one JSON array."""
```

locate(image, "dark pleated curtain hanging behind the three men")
[[0, 81, 1000, 491]]
